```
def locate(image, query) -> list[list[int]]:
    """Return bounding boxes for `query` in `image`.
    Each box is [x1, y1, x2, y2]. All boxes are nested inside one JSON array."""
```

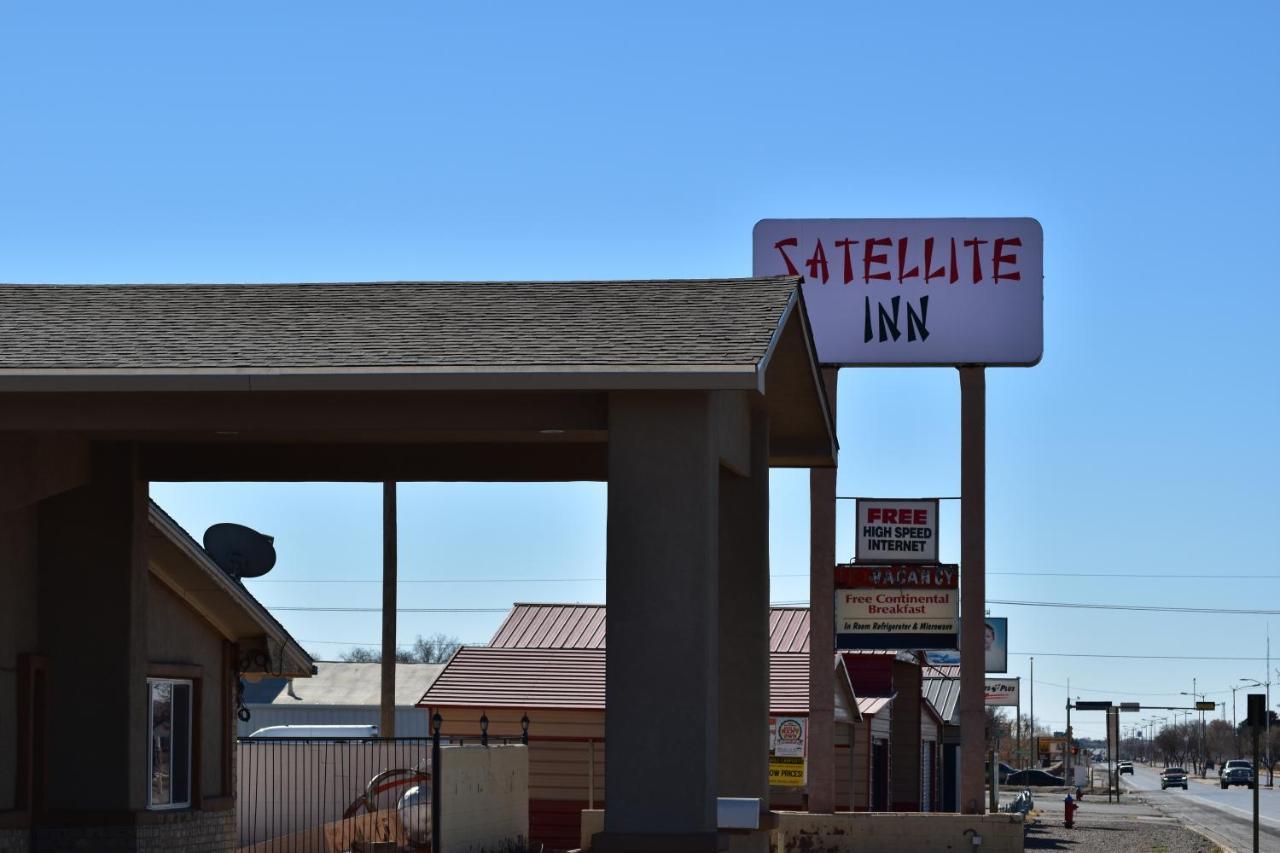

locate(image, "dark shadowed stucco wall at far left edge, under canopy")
[[0, 507, 38, 811]]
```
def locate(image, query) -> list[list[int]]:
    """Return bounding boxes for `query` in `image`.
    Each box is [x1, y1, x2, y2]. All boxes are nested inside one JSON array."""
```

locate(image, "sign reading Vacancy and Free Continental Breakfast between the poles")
[[836, 565, 960, 649]]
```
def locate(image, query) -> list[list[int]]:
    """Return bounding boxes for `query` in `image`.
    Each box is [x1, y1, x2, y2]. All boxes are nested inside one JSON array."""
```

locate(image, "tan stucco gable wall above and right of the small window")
[[147, 576, 232, 797]]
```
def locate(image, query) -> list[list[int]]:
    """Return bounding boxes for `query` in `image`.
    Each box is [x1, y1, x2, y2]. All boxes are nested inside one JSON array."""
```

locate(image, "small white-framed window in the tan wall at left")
[[147, 679, 192, 808]]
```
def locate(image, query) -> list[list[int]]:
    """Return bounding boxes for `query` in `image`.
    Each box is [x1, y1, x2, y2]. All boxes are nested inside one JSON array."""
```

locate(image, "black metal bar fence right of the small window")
[[237, 738, 431, 853]]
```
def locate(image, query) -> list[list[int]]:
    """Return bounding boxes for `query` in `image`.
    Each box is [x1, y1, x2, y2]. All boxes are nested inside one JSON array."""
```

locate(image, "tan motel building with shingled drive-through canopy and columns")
[[0, 275, 837, 853]]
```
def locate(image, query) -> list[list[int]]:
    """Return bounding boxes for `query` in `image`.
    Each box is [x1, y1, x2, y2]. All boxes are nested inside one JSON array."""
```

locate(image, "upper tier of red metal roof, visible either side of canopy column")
[[489, 596, 809, 653]]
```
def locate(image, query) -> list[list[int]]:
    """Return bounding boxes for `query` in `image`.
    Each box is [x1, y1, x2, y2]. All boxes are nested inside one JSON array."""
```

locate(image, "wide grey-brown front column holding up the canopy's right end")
[[593, 392, 719, 853]]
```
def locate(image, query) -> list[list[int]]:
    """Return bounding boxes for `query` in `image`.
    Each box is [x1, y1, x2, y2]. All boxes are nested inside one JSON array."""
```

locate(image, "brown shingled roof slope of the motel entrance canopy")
[[0, 278, 799, 373]]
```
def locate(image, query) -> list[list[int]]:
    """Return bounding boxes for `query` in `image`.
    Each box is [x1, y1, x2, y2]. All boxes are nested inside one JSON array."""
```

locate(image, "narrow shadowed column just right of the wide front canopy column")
[[719, 404, 769, 809]]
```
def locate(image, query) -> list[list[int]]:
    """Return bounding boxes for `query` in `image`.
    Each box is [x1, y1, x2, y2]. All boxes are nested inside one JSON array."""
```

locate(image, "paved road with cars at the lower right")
[[1120, 763, 1280, 853]]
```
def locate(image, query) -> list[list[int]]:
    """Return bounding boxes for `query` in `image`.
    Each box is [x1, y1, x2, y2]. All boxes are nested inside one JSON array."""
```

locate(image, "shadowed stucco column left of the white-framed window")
[[38, 444, 149, 809]]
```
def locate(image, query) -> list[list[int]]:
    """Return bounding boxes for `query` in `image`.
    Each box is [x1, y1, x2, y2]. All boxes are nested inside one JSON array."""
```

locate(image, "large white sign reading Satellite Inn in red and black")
[[751, 219, 1044, 366]]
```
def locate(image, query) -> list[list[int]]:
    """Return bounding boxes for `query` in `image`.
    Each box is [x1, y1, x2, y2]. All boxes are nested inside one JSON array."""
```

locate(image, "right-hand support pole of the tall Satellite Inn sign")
[[957, 366, 987, 815]]
